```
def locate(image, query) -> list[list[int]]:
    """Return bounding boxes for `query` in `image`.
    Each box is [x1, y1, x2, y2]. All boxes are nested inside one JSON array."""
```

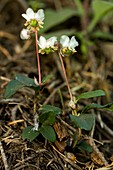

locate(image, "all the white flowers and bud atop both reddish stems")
[[20, 8, 78, 56]]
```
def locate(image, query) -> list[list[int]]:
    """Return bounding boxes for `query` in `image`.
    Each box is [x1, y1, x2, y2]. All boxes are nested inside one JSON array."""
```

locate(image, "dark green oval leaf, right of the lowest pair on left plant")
[[39, 125, 56, 142]]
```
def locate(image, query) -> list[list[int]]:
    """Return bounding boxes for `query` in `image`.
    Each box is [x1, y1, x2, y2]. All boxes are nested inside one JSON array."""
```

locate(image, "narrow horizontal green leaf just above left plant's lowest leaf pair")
[[39, 105, 61, 115]]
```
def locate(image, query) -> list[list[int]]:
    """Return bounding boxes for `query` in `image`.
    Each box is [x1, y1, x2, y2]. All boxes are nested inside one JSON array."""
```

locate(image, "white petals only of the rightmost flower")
[[60, 35, 78, 52]]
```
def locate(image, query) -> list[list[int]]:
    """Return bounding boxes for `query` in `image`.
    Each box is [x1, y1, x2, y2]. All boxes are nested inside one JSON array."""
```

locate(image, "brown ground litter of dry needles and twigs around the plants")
[[0, 1, 113, 170]]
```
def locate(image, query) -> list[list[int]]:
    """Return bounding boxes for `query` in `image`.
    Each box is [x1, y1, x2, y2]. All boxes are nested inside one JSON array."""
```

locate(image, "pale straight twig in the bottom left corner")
[[0, 141, 9, 170]]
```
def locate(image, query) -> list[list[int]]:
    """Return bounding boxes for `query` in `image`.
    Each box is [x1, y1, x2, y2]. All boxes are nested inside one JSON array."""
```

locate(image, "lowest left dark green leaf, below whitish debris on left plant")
[[22, 126, 40, 141]]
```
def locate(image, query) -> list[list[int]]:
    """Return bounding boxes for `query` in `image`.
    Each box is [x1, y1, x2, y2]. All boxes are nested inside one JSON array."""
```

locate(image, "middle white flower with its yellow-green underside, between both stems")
[[38, 36, 57, 54]]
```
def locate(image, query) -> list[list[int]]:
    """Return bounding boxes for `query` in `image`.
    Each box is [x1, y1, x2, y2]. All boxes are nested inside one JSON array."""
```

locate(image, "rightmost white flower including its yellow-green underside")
[[60, 35, 78, 54]]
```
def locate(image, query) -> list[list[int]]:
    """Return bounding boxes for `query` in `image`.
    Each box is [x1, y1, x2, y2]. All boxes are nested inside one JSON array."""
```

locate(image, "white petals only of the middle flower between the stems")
[[38, 36, 57, 49]]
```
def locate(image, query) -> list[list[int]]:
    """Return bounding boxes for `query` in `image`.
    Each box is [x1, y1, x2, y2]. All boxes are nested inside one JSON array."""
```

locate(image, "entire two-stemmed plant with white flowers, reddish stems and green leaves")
[[4, 5, 112, 152]]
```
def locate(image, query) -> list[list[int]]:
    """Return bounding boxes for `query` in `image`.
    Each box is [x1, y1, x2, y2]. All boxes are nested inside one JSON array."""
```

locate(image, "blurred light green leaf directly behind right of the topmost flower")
[[40, 8, 79, 34]]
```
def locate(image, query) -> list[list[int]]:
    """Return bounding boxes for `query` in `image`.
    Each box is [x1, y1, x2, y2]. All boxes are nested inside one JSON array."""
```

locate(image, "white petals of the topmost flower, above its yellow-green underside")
[[22, 8, 44, 22]]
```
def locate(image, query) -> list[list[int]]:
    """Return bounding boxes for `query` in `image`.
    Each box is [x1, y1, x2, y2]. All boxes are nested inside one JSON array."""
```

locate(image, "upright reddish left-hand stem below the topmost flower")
[[35, 30, 42, 86]]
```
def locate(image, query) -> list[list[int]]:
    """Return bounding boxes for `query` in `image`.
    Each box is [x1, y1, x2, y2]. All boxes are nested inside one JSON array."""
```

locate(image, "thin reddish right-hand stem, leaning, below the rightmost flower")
[[59, 52, 73, 100]]
